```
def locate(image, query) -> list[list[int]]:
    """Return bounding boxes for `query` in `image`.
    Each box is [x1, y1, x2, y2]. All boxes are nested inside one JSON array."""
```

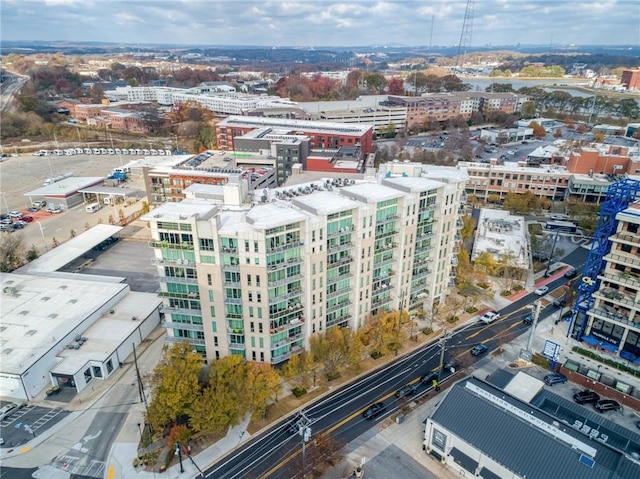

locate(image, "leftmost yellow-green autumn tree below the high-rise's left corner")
[[147, 341, 203, 429]]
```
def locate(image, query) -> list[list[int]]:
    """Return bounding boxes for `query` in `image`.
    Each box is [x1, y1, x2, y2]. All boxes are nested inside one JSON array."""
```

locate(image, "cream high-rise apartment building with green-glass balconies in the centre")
[[144, 163, 466, 364]]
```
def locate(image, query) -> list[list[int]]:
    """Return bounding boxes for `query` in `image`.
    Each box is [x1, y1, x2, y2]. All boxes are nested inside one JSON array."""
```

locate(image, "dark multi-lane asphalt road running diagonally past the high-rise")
[[205, 248, 588, 479]]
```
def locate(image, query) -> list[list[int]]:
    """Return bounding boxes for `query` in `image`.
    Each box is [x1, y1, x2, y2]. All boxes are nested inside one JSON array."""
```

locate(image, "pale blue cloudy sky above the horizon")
[[0, 0, 640, 47]]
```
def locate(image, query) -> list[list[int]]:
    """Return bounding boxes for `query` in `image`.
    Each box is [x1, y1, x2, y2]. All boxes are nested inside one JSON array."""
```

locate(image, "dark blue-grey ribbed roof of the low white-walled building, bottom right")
[[431, 378, 640, 479]]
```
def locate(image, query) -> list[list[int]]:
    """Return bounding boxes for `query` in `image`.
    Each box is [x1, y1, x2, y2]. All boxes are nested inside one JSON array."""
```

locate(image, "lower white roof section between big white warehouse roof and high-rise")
[[51, 292, 162, 374]]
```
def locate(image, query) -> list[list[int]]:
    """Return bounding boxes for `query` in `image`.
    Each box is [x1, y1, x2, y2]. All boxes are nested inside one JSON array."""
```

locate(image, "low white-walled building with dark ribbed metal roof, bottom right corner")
[[424, 377, 640, 479]]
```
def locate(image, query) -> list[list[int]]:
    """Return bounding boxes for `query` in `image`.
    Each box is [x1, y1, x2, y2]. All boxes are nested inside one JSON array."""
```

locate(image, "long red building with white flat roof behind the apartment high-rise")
[[216, 116, 373, 153]]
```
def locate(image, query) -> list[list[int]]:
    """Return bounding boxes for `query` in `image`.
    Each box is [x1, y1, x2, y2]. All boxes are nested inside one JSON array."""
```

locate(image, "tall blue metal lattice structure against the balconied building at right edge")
[[567, 178, 640, 341]]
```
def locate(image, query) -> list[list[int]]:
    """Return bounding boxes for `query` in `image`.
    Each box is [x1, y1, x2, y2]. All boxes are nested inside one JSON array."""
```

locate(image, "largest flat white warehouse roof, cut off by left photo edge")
[[0, 273, 129, 375]]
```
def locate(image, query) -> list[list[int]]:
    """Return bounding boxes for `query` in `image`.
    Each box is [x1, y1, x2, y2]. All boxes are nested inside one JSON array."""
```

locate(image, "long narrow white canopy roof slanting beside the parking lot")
[[17, 224, 122, 274]]
